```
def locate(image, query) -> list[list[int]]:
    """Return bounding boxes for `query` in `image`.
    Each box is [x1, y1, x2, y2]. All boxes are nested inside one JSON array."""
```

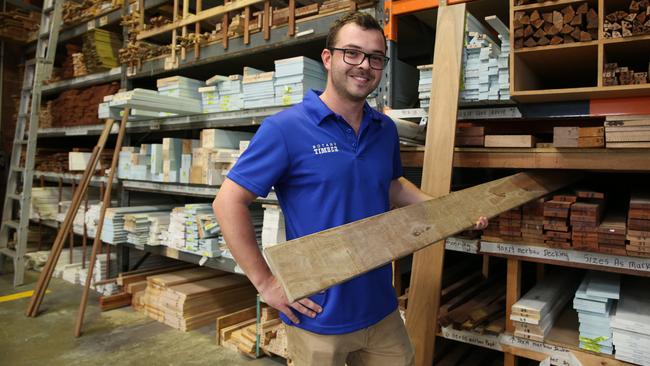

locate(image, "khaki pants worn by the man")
[[286, 311, 415, 366]]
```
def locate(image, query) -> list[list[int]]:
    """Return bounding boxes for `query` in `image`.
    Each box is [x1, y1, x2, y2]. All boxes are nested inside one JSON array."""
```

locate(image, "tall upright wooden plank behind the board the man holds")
[[406, 4, 464, 366]]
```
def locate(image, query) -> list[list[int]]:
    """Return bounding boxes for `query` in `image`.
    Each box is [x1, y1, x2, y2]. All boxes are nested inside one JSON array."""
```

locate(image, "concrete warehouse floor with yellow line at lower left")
[[0, 265, 285, 366]]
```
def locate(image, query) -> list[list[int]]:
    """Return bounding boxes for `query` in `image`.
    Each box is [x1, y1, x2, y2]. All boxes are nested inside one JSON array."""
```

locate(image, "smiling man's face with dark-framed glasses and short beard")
[[321, 23, 386, 101]]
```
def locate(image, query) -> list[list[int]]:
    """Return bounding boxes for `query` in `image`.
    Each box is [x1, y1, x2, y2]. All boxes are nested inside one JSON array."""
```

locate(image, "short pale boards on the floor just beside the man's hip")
[[217, 304, 288, 358]]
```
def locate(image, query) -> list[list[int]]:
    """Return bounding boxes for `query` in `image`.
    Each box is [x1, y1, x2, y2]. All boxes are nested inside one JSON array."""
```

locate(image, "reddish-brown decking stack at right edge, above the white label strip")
[[626, 193, 650, 257]]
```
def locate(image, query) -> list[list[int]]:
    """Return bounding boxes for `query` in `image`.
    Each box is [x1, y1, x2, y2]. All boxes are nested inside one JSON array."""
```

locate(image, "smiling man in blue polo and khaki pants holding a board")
[[213, 12, 487, 366]]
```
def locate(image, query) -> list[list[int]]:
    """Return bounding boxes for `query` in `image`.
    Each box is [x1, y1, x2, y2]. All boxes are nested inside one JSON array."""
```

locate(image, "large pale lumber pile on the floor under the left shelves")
[[143, 268, 257, 331]]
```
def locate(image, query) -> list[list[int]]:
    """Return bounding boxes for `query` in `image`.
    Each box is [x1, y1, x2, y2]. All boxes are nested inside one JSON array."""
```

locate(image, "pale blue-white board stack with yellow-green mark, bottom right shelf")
[[573, 271, 621, 355]]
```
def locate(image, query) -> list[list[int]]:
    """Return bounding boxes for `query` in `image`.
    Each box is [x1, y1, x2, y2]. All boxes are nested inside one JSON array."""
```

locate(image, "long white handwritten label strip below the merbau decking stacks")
[[481, 241, 650, 272]]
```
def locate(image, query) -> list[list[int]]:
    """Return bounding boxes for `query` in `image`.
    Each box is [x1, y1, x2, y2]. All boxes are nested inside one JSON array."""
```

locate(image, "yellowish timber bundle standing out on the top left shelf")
[[83, 28, 122, 73]]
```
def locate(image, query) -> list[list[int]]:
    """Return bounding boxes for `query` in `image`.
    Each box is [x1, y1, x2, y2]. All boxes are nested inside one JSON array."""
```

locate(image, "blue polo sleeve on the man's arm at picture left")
[[228, 119, 289, 197]]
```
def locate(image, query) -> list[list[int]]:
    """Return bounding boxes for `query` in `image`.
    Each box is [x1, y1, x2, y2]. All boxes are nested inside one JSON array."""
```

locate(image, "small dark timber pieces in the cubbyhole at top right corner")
[[603, 0, 650, 38]]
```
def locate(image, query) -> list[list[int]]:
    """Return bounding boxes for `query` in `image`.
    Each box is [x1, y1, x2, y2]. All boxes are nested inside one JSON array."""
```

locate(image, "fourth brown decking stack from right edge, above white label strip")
[[544, 194, 577, 249]]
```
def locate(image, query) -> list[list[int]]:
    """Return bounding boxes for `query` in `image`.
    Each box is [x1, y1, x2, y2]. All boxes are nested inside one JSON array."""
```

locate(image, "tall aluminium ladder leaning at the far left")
[[0, 0, 63, 286]]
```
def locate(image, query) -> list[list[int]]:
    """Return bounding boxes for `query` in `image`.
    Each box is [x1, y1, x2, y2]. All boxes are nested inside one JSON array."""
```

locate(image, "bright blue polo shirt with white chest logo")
[[228, 91, 402, 334]]
